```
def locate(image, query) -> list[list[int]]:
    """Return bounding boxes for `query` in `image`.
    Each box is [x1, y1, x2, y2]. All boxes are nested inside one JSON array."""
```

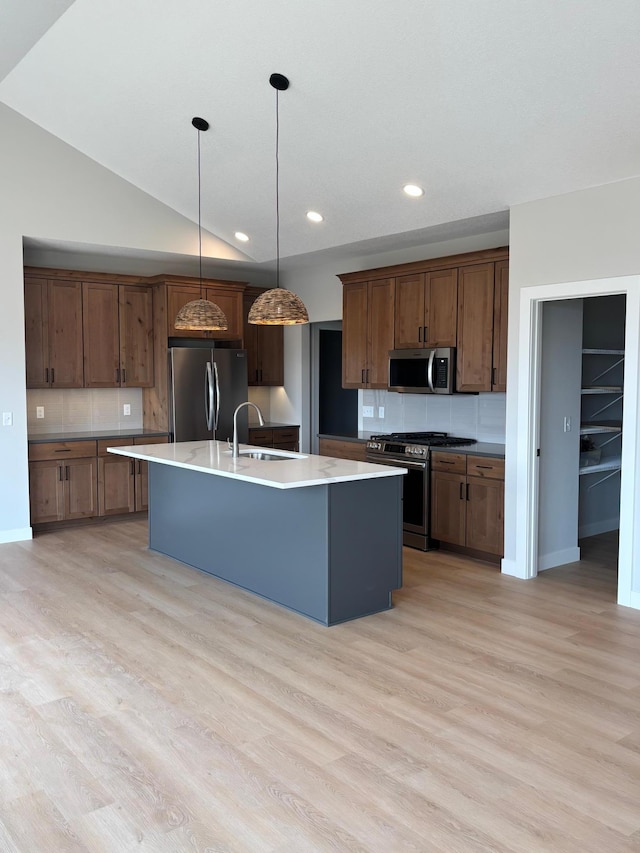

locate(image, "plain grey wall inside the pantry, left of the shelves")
[[538, 299, 582, 570]]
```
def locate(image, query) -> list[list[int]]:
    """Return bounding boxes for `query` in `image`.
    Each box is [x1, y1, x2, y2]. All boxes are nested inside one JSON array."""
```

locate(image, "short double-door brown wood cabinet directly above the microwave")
[[395, 268, 458, 349]]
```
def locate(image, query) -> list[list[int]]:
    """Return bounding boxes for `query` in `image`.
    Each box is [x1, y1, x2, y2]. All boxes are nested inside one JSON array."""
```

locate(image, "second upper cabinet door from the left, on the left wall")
[[48, 281, 84, 388]]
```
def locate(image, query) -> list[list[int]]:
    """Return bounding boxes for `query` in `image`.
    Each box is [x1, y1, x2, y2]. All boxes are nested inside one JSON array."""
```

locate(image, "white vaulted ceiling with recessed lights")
[[0, 0, 640, 270]]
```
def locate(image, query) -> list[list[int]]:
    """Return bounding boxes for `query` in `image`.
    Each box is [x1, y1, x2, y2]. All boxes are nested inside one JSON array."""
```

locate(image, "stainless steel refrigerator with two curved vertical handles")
[[169, 346, 248, 443]]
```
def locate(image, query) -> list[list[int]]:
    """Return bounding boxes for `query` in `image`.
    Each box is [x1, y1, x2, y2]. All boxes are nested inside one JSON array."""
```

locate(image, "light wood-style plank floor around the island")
[[0, 520, 640, 853]]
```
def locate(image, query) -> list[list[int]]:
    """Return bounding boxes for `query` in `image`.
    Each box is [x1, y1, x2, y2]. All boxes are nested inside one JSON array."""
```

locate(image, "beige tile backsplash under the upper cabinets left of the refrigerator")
[[27, 388, 142, 435]]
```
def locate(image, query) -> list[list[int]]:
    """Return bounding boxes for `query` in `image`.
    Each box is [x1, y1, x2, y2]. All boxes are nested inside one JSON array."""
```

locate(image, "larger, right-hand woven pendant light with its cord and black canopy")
[[247, 74, 309, 326]]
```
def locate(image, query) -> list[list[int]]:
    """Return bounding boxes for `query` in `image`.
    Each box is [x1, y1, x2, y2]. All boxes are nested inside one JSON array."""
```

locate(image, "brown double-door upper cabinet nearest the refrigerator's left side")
[[82, 282, 154, 388]]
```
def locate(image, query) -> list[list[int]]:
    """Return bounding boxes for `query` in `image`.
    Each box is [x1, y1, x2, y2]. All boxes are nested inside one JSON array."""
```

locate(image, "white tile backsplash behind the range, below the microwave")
[[358, 389, 506, 444]]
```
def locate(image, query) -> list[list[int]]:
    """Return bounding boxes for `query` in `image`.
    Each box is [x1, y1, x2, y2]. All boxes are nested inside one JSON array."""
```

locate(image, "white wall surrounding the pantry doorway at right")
[[510, 173, 640, 606]]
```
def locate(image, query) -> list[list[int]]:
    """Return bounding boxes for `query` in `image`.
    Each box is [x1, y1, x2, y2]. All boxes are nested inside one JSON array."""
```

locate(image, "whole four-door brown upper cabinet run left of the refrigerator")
[[24, 268, 154, 388]]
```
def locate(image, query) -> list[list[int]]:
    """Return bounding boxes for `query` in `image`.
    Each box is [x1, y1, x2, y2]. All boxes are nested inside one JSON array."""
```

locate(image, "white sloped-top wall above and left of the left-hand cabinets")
[[0, 105, 252, 542]]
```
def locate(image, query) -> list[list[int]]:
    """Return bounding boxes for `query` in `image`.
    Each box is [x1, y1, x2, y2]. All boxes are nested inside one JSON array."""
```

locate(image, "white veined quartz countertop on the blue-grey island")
[[108, 441, 407, 489]]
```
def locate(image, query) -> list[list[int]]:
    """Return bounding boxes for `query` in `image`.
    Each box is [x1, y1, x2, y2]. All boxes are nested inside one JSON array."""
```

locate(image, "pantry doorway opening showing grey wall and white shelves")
[[537, 294, 626, 592]]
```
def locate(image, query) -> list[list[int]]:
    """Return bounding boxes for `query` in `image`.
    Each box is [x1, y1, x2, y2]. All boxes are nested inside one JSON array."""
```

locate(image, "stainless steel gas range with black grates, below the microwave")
[[366, 432, 476, 551]]
